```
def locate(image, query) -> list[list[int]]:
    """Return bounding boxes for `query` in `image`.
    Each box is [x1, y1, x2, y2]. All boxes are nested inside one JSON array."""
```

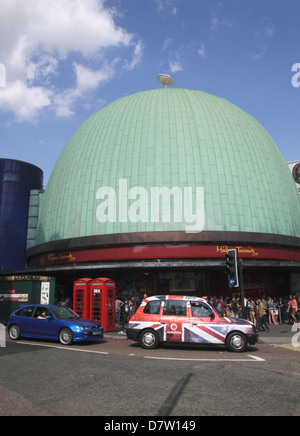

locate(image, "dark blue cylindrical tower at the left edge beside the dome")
[[0, 159, 43, 269]]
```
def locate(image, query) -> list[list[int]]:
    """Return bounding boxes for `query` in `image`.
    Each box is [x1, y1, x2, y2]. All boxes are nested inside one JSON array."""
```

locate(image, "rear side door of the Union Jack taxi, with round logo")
[[161, 300, 188, 342]]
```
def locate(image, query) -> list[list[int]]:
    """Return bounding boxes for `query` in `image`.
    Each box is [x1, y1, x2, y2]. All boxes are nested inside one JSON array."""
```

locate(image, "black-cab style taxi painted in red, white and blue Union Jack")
[[126, 295, 258, 352]]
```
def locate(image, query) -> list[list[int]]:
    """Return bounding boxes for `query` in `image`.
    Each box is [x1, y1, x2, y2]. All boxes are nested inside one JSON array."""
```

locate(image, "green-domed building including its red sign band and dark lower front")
[[27, 89, 300, 296]]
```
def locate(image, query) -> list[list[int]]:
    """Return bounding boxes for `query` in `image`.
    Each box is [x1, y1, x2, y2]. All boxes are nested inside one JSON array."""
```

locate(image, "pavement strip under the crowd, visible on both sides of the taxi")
[[104, 324, 300, 345]]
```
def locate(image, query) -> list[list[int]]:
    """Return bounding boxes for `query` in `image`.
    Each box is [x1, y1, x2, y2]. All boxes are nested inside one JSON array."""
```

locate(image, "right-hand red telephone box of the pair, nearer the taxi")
[[90, 277, 116, 332]]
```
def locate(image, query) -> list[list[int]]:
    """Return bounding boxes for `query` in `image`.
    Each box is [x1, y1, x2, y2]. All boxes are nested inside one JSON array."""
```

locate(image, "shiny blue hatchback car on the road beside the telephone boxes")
[[7, 304, 103, 345]]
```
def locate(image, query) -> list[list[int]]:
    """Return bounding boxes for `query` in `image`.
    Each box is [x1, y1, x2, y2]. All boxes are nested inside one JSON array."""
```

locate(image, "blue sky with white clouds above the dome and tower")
[[0, 0, 300, 184]]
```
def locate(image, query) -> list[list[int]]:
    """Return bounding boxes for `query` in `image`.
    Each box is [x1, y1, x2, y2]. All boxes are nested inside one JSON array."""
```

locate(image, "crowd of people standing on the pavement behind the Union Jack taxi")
[[115, 294, 300, 334]]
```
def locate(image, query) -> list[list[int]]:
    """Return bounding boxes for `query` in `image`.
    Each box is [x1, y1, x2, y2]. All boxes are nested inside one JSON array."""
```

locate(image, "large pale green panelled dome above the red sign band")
[[36, 89, 300, 244]]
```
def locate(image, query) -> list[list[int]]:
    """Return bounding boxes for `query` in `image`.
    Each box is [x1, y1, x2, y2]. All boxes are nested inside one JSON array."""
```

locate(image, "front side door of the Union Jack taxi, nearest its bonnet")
[[182, 301, 226, 344]]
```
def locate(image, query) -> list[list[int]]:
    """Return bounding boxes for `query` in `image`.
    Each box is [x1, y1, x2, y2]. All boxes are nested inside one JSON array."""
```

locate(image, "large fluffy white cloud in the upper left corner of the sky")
[[0, 0, 142, 121]]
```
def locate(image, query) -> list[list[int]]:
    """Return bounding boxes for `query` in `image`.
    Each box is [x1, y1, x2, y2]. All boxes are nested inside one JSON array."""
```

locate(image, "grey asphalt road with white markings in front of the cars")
[[0, 328, 300, 417]]
